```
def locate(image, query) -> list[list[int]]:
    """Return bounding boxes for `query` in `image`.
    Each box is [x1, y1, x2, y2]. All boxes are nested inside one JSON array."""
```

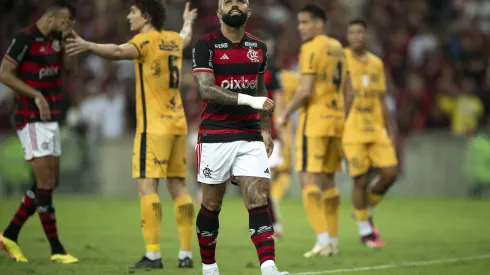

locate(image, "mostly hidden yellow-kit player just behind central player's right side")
[[269, 69, 299, 238]]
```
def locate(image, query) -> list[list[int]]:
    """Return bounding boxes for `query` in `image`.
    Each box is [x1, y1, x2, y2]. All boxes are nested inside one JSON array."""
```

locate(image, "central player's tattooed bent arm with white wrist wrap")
[[192, 40, 272, 110]]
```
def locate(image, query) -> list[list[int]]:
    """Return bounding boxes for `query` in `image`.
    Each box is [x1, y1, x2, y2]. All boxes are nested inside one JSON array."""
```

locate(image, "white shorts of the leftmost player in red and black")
[[17, 122, 61, 161]]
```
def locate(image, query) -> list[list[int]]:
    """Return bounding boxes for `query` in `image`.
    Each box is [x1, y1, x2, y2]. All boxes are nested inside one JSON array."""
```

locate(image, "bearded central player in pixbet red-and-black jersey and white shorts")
[[193, 0, 289, 275]]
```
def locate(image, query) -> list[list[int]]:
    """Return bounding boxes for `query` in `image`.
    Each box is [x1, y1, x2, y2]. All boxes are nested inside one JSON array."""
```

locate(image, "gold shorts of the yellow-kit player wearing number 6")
[[133, 133, 187, 179]]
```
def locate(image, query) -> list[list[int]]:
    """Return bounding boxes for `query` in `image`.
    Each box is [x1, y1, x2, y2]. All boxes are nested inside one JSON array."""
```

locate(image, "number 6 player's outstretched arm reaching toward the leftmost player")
[[66, 33, 138, 60]]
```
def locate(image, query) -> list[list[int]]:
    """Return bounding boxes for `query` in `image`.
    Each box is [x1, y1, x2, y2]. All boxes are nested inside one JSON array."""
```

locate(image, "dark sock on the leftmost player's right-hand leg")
[[36, 188, 66, 255]]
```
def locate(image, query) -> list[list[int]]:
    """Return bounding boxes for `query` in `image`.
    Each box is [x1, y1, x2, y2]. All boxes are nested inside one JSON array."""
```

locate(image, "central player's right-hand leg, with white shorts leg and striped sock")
[[232, 141, 289, 275]]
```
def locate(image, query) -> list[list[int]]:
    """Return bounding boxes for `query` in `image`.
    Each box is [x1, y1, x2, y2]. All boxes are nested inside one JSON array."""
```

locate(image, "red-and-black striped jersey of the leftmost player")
[[4, 25, 63, 129]]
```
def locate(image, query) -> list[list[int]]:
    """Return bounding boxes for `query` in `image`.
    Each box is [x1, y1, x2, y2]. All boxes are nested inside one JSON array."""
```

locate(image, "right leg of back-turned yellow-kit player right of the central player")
[[320, 138, 343, 255]]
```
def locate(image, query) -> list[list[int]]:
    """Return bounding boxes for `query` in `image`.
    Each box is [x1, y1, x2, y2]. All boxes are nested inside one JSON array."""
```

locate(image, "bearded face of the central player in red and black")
[[218, 0, 251, 28]]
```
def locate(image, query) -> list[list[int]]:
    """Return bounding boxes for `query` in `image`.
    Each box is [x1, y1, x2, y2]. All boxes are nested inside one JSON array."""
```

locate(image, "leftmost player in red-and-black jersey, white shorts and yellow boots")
[[0, 1, 78, 264]]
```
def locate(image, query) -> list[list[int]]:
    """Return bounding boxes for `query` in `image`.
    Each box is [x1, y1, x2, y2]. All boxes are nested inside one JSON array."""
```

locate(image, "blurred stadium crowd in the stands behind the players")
[[0, 0, 490, 139]]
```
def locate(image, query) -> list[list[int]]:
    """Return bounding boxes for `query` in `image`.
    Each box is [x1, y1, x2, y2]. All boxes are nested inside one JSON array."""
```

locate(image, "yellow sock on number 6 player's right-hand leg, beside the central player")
[[174, 194, 194, 260]]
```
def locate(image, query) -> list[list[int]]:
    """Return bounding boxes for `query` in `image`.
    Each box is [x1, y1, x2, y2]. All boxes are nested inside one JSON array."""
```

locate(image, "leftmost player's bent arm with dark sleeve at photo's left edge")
[[0, 34, 42, 98]]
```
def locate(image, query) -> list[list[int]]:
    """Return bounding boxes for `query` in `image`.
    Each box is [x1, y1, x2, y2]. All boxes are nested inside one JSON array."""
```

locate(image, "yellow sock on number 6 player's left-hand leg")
[[140, 193, 162, 261]]
